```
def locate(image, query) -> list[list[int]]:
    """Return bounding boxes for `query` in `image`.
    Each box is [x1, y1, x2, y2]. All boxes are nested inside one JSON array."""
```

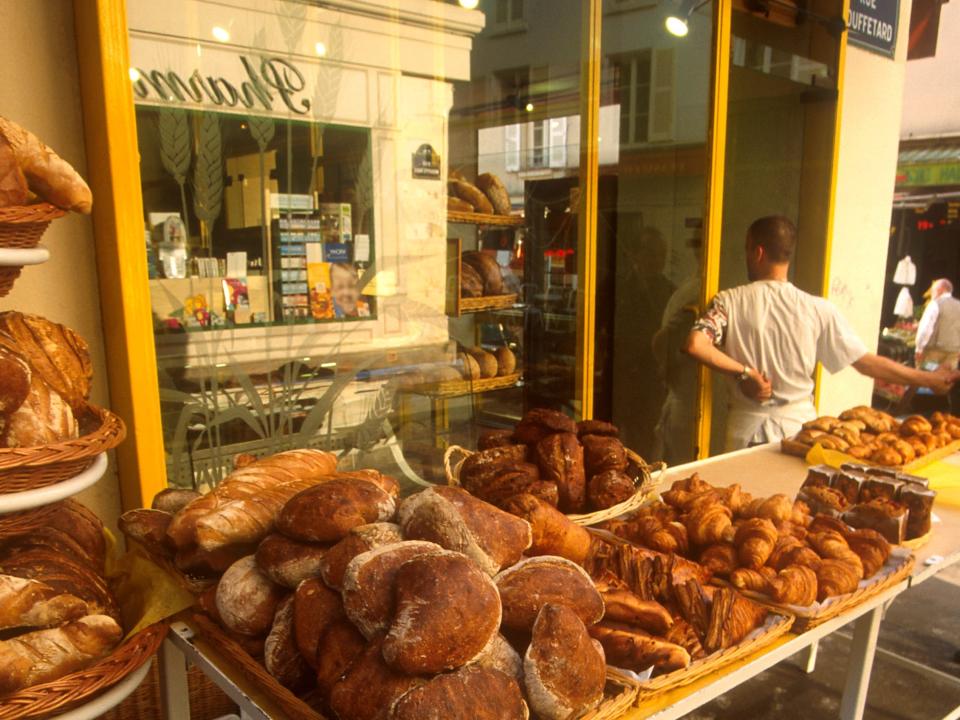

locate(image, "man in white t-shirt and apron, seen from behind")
[[684, 215, 960, 451]]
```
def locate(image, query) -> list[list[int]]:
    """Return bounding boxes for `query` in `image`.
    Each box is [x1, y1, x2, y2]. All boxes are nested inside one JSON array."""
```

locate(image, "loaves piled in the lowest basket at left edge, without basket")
[[0, 500, 123, 699]]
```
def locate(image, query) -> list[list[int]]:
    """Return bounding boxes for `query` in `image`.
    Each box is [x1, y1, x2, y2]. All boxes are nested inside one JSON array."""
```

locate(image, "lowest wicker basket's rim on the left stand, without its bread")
[[0, 623, 167, 720]]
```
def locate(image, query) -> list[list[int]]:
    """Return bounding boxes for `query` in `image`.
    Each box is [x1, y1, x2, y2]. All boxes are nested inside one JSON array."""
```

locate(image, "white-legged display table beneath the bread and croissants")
[[154, 444, 960, 720]]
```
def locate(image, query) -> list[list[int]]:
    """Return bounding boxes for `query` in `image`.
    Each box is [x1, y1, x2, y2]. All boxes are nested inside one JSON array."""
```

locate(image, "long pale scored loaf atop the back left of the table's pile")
[[167, 450, 337, 550]]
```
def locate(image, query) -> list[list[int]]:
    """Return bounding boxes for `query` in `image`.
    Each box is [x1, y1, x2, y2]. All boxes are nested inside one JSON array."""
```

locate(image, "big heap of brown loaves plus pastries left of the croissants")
[[121, 450, 766, 720]]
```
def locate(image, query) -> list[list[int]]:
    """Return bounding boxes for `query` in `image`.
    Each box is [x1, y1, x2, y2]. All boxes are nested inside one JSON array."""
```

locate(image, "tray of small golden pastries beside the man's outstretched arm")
[[781, 405, 960, 470]]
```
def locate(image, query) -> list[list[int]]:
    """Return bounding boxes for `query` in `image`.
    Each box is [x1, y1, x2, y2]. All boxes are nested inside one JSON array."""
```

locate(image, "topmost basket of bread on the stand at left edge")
[[0, 117, 92, 297]]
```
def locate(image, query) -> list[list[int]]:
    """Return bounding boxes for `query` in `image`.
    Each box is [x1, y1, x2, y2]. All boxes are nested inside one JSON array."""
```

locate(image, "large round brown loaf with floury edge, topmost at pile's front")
[[383, 551, 501, 675]]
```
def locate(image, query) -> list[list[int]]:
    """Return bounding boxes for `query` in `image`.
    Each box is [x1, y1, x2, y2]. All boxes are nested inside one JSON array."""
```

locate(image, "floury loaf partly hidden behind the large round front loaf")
[[342, 540, 442, 638]]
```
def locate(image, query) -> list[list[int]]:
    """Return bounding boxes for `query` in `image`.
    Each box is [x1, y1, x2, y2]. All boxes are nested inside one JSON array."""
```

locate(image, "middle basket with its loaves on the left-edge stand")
[[0, 311, 126, 493]]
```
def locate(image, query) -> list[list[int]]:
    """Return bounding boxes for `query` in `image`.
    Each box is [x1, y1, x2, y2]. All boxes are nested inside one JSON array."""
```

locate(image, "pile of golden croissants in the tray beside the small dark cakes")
[[606, 474, 891, 606]]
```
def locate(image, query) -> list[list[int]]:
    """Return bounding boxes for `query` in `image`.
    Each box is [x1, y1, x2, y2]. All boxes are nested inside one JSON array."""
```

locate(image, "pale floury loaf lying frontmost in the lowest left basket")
[[0, 615, 123, 695]]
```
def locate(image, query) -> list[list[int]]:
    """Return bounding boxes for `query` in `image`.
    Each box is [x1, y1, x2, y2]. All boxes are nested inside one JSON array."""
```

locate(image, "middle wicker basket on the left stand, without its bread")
[[0, 405, 127, 493]]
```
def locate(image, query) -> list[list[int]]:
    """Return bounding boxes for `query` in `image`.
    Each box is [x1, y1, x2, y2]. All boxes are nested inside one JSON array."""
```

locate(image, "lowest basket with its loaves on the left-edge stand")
[[0, 500, 166, 720]]
